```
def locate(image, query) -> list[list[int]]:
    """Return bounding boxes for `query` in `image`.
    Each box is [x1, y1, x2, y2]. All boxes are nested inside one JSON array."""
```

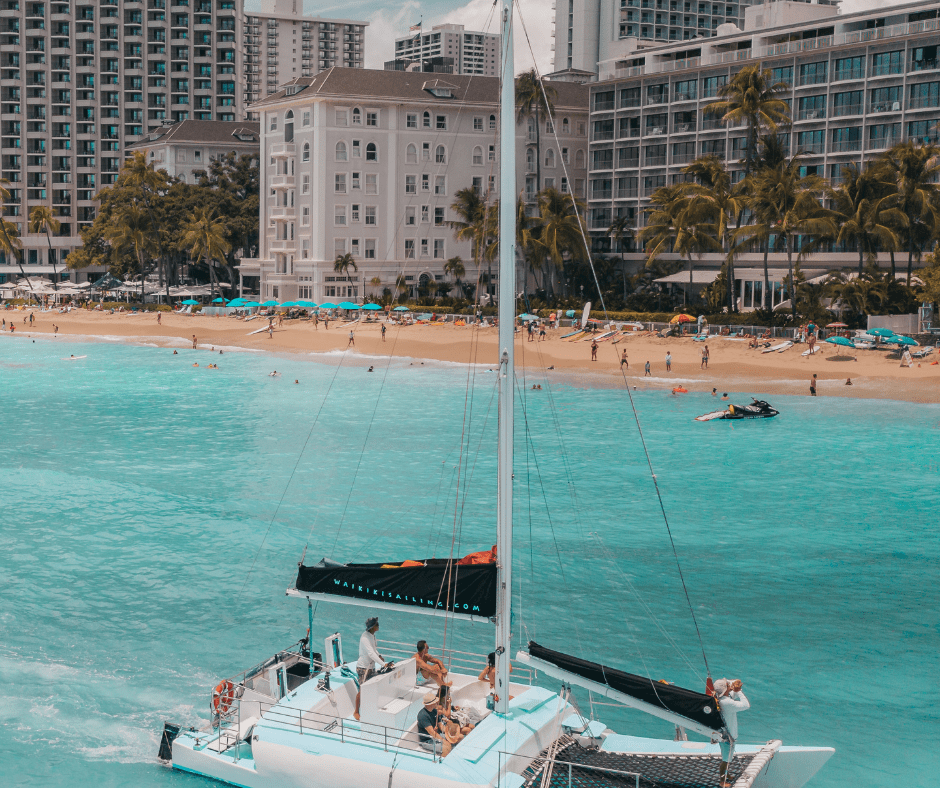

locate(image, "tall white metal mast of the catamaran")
[[495, 0, 516, 714]]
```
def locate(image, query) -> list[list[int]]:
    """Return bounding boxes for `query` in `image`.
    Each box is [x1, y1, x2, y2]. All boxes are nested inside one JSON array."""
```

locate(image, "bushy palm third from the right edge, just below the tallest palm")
[[735, 156, 836, 322]]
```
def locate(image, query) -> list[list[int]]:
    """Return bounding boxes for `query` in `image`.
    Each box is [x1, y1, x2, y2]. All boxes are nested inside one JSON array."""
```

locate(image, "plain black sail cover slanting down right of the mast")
[[529, 641, 724, 731]]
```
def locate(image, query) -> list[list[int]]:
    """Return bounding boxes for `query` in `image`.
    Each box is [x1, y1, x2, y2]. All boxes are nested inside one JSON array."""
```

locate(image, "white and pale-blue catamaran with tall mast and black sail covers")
[[160, 0, 833, 788]]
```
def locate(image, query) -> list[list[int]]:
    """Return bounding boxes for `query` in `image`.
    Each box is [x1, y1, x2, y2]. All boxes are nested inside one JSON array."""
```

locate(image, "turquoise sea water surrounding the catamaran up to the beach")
[[0, 336, 940, 788]]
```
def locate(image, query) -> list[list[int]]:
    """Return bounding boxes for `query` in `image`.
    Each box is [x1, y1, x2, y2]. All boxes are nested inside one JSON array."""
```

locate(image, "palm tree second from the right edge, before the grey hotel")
[[828, 163, 906, 276]]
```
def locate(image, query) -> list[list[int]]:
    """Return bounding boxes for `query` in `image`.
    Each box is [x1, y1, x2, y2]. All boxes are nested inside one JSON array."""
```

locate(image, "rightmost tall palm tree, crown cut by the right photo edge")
[[877, 140, 940, 286]]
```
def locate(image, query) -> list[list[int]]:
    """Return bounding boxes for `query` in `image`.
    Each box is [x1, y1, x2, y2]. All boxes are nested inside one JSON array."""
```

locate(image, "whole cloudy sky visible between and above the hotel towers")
[[245, 0, 916, 74]]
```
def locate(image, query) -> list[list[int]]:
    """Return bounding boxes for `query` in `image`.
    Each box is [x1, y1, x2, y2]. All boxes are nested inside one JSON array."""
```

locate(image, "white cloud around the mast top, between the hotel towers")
[[366, 0, 554, 73]]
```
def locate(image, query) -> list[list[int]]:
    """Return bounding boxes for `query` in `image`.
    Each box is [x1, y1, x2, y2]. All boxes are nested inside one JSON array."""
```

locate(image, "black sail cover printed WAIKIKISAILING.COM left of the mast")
[[296, 558, 497, 618]]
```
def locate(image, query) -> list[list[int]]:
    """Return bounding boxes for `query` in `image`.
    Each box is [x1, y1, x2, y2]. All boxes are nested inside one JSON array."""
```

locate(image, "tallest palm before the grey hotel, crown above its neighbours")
[[705, 65, 790, 177]]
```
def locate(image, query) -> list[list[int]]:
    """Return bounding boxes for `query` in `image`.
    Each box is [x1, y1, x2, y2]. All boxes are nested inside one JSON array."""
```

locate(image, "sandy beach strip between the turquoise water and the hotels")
[[7, 310, 940, 403]]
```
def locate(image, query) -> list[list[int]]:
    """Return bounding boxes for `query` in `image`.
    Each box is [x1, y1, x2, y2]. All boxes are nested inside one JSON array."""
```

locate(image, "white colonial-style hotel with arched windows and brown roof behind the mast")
[[241, 68, 589, 303]]
